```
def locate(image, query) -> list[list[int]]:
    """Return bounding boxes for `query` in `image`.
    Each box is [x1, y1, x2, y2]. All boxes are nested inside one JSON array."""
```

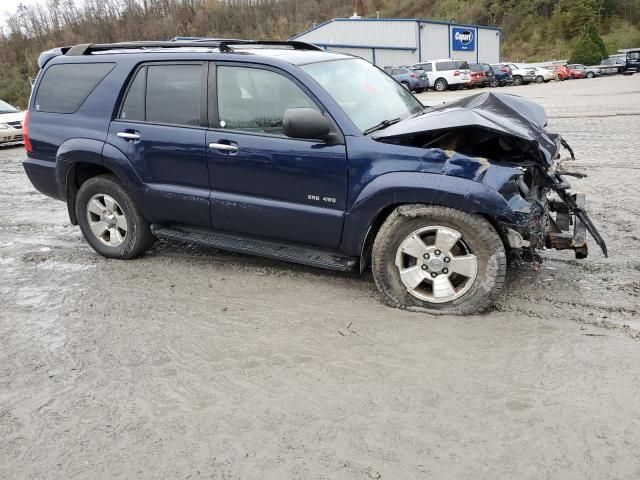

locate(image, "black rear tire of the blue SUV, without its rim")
[[75, 175, 155, 260]]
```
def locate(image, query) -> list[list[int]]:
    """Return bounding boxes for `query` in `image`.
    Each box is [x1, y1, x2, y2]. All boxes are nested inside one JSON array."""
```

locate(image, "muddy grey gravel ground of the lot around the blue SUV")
[[0, 75, 640, 479]]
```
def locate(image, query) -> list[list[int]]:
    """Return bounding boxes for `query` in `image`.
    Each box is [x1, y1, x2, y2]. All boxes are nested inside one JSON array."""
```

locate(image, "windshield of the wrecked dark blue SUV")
[[301, 58, 424, 132]]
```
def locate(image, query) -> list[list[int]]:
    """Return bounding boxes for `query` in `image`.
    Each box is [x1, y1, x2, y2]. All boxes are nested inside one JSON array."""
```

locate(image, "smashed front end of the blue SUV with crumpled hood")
[[373, 93, 607, 258]]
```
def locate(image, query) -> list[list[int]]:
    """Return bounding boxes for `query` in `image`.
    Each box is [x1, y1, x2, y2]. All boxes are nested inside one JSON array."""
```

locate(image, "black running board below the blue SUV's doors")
[[151, 225, 358, 271]]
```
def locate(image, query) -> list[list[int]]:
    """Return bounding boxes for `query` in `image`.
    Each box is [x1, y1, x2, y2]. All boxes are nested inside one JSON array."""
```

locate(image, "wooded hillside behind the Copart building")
[[0, 0, 640, 107]]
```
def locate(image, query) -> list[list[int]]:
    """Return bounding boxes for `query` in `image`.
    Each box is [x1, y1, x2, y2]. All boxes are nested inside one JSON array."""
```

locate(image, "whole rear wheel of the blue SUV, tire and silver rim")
[[76, 175, 154, 259]]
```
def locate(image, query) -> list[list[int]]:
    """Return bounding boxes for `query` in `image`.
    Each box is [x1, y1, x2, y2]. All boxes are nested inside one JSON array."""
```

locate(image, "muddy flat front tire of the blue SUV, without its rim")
[[371, 204, 507, 315]]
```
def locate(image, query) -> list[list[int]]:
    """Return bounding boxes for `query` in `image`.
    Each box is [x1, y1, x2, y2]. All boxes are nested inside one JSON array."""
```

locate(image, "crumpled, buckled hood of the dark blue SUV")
[[373, 92, 560, 164]]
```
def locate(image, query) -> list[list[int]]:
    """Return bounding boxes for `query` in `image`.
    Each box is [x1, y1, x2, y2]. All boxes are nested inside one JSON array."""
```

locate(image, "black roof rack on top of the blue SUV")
[[66, 37, 323, 56]]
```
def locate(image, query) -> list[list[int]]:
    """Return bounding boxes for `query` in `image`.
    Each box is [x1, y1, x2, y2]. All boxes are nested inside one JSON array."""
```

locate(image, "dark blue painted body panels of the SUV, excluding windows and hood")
[[24, 47, 525, 264]]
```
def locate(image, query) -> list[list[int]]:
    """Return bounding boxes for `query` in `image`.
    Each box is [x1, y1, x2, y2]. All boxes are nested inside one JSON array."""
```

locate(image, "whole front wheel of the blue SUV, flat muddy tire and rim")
[[372, 204, 507, 315]]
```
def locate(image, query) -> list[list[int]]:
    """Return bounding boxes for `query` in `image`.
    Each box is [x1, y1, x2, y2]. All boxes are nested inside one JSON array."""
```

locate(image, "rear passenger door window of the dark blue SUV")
[[118, 65, 203, 126]]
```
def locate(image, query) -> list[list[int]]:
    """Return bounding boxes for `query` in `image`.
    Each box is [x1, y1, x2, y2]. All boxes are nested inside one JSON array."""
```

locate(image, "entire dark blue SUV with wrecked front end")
[[24, 39, 606, 314]]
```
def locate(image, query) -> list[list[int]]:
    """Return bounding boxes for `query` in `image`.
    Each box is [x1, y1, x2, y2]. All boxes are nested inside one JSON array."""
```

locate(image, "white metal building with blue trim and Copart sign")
[[291, 18, 502, 67]]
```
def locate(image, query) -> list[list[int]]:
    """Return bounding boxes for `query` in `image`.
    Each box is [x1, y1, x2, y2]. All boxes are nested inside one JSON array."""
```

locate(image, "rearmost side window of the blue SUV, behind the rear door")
[[35, 63, 115, 113]]
